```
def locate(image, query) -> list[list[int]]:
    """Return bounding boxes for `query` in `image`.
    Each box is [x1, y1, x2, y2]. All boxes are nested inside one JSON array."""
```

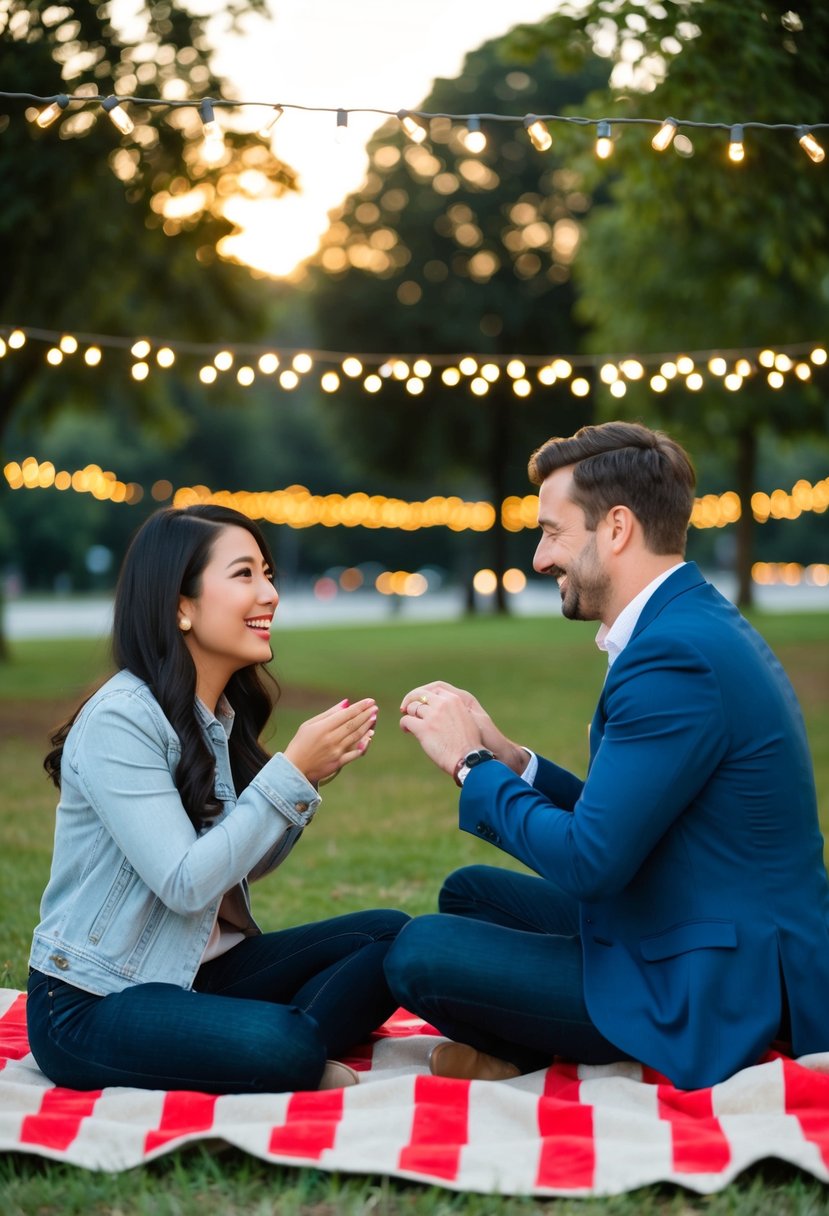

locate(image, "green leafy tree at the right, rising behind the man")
[[503, 0, 829, 604]]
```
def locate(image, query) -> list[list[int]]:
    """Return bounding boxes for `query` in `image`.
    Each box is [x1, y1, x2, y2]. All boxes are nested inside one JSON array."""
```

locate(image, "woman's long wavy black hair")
[[44, 505, 278, 829]]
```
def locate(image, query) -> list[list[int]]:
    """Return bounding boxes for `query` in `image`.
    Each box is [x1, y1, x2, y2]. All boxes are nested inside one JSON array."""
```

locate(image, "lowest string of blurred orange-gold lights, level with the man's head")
[[4, 456, 829, 533]]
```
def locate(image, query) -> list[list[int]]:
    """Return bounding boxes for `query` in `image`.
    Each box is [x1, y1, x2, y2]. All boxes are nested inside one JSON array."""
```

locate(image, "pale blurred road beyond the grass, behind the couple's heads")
[[5, 578, 829, 641]]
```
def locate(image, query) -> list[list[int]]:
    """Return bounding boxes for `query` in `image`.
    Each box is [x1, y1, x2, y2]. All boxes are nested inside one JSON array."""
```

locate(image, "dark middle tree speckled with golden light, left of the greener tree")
[[311, 40, 602, 610]]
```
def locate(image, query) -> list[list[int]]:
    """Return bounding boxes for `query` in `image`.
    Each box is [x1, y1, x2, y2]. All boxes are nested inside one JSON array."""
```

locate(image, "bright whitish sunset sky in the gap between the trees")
[[201, 0, 556, 275]]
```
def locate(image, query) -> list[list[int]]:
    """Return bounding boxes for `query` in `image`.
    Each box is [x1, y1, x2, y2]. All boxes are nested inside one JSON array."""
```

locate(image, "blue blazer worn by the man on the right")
[[459, 563, 829, 1088]]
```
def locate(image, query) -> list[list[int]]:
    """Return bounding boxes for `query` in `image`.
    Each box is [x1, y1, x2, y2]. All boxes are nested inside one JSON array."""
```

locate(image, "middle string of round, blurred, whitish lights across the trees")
[[0, 323, 829, 399]]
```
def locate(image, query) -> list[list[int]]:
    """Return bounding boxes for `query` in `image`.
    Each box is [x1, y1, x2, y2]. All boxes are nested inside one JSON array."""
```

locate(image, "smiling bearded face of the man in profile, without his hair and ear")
[[532, 466, 610, 620]]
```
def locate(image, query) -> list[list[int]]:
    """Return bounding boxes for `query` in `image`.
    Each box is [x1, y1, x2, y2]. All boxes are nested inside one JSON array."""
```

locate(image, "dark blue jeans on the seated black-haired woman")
[[27, 911, 408, 1093]]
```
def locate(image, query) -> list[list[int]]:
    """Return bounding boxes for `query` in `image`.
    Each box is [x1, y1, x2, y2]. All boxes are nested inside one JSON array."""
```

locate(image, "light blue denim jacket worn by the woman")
[[29, 671, 320, 996]]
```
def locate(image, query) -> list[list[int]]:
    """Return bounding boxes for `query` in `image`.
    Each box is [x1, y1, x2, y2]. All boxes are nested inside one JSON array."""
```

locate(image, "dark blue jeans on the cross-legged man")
[[385, 866, 626, 1073]]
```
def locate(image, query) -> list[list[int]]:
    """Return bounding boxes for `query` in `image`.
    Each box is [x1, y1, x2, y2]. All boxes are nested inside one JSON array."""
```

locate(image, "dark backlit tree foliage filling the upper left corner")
[[0, 0, 295, 447]]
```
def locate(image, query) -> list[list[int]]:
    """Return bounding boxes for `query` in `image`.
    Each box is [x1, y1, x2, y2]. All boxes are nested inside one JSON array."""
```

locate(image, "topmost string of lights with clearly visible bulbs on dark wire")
[[0, 91, 829, 163]]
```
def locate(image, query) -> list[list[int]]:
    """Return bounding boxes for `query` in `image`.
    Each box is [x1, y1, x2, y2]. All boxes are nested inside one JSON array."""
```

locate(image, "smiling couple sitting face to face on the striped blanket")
[[28, 422, 829, 1093]]
